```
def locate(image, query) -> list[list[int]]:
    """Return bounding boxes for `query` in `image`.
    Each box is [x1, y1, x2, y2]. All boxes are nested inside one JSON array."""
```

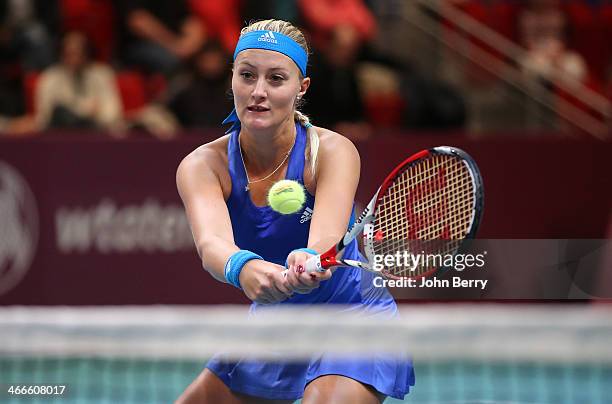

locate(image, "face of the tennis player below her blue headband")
[[232, 49, 308, 130]]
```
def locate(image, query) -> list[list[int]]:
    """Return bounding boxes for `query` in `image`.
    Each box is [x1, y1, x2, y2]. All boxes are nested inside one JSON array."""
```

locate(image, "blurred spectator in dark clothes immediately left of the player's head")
[[168, 41, 233, 128]]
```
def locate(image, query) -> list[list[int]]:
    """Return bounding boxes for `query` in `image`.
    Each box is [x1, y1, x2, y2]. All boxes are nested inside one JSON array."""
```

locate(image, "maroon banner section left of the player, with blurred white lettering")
[[0, 137, 247, 305]]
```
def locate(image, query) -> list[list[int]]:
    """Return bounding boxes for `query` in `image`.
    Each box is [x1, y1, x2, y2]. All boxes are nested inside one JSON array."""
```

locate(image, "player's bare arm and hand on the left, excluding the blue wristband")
[[176, 147, 292, 303]]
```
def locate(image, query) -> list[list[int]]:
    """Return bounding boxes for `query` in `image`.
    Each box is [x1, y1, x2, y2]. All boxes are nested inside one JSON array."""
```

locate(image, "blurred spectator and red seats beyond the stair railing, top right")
[[450, 0, 612, 121]]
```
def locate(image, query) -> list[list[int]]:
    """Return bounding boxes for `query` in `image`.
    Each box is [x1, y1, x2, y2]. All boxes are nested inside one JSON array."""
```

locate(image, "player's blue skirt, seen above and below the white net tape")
[[206, 268, 415, 400]]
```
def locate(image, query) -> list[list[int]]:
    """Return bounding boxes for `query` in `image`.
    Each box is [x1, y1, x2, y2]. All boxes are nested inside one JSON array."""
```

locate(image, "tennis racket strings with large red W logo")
[[374, 155, 475, 277]]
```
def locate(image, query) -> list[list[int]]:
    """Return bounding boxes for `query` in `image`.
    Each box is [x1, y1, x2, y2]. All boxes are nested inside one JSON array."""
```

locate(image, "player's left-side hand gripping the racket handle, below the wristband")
[[240, 260, 293, 304]]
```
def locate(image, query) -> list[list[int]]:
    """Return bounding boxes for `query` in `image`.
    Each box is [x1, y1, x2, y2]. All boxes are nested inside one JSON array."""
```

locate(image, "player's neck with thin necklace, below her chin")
[[240, 120, 296, 174]]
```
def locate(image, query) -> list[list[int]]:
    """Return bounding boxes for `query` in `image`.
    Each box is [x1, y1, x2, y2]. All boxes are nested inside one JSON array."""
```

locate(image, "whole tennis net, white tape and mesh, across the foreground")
[[0, 305, 612, 403]]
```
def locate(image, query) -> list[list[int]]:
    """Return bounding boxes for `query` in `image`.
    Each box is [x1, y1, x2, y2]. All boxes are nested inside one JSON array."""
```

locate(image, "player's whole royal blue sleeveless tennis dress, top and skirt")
[[206, 124, 415, 400]]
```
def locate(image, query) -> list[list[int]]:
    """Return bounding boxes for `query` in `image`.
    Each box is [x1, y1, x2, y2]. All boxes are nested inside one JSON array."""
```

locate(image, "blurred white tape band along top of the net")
[[0, 304, 612, 363]]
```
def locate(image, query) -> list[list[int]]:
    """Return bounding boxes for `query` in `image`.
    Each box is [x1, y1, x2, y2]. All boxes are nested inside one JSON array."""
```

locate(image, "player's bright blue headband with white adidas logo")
[[223, 31, 308, 133]]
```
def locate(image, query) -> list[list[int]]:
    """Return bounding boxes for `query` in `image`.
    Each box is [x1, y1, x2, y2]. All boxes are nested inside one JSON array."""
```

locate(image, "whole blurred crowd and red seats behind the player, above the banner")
[[0, 0, 612, 139]]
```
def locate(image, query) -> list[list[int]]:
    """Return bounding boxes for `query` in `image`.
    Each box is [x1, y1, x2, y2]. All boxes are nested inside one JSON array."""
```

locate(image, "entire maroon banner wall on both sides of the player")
[[0, 132, 612, 305]]
